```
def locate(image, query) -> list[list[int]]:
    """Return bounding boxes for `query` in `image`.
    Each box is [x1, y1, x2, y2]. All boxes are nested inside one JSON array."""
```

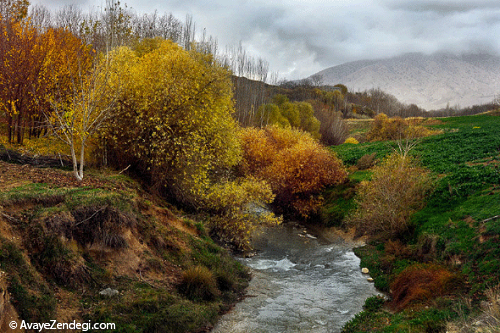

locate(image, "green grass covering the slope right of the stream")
[[329, 114, 500, 332]]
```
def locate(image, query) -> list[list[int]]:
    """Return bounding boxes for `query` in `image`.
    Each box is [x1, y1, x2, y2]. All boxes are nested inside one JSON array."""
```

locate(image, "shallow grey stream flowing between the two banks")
[[212, 223, 378, 333]]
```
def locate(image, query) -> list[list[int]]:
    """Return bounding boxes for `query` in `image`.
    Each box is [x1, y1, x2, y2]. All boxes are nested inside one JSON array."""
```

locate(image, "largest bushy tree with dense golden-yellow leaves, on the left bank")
[[106, 39, 240, 206]]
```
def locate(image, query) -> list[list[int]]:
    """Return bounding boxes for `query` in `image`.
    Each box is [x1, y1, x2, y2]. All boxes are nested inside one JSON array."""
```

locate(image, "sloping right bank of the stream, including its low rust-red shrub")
[[327, 112, 500, 333]]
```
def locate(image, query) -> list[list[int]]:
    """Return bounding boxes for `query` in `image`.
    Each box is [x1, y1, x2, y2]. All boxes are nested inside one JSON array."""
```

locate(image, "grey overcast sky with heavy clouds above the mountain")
[[31, 0, 500, 79]]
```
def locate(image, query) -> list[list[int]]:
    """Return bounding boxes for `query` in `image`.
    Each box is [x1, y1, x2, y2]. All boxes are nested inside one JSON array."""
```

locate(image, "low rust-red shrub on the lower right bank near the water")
[[391, 264, 459, 311]]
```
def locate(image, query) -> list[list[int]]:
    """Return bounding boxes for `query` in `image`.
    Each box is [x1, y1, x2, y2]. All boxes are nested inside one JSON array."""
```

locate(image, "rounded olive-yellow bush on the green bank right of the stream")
[[349, 153, 432, 236]]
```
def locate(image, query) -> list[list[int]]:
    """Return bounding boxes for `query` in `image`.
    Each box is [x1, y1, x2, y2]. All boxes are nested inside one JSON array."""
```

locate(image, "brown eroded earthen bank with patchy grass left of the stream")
[[0, 159, 249, 333]]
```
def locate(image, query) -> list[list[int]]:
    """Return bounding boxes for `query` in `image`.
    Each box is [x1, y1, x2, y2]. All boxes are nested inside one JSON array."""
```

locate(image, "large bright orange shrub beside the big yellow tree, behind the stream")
[[240, 127, 346, 218]]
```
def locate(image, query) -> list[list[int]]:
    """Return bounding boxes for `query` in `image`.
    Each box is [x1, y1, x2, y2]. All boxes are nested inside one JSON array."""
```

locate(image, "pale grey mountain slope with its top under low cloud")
[[315, 53, 500, 110]]
